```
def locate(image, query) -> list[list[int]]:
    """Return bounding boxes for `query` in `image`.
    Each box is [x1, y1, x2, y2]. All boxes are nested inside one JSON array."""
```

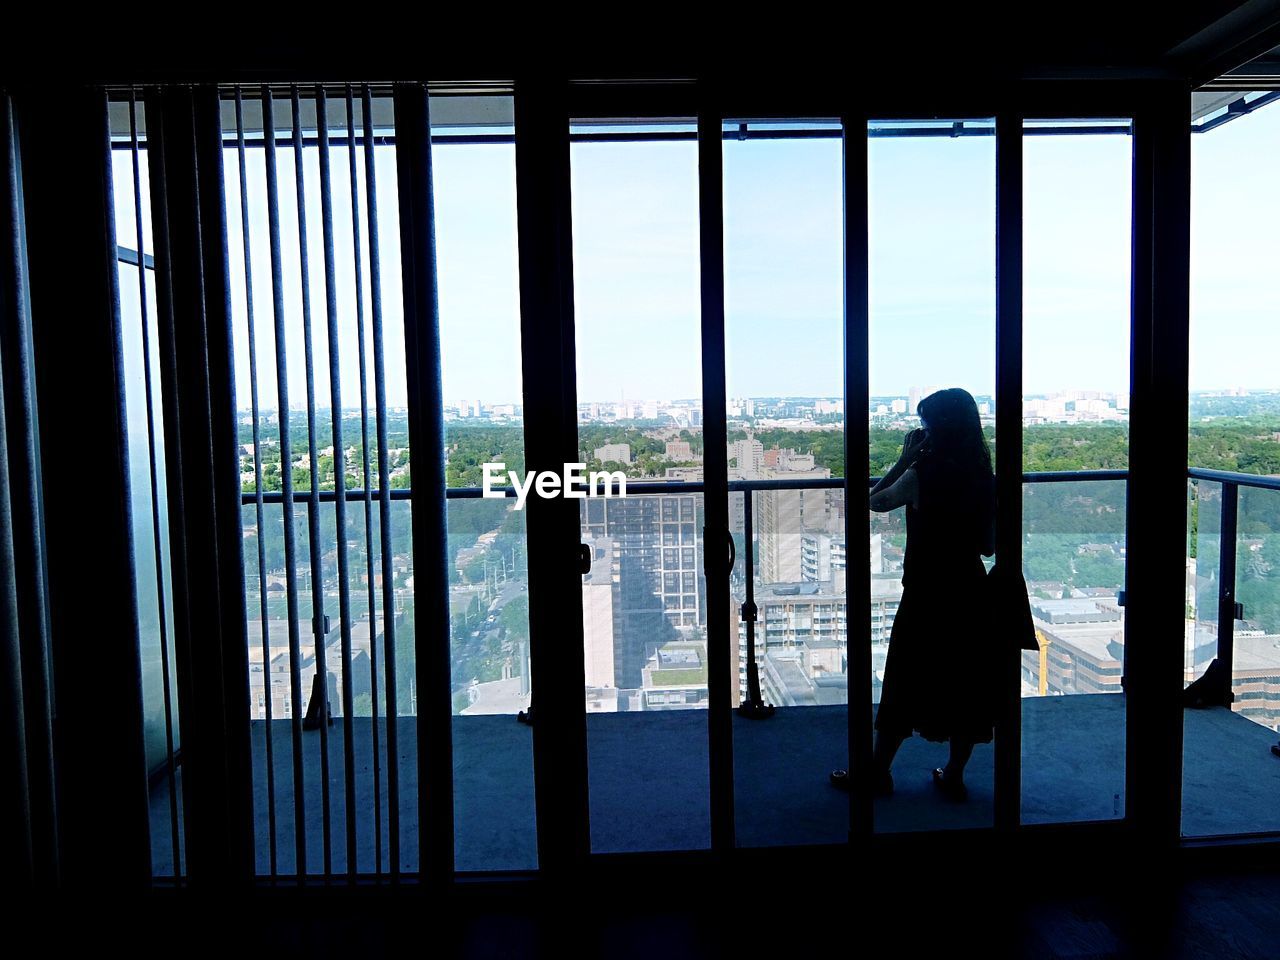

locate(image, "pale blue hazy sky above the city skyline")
[[115, 105, 1280, 410]]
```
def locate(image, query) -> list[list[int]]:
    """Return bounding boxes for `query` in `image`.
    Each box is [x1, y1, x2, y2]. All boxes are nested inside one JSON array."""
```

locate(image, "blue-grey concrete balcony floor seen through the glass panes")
[[152, 695, 1280, 874]]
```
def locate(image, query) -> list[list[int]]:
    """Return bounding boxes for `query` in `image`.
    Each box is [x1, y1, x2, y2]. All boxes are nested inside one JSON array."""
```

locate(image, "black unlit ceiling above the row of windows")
[[0, 0, 1280, 86]]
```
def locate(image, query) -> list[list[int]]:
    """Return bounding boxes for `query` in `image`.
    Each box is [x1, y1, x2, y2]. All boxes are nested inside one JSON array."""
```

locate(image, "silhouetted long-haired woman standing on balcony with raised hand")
[[831, 388, 996, 800]]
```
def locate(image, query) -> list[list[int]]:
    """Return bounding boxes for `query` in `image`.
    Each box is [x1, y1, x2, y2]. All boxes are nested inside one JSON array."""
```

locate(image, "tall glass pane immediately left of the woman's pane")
[[723, 120, 849, 846]]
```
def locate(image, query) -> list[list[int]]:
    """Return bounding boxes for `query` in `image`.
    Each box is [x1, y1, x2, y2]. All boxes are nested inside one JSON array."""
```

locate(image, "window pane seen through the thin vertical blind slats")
[[223, 90, 419, 874]]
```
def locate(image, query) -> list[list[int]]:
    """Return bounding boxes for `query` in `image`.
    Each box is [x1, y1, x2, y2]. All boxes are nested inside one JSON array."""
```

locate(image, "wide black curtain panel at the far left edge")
[[17, 83, 151, 891]]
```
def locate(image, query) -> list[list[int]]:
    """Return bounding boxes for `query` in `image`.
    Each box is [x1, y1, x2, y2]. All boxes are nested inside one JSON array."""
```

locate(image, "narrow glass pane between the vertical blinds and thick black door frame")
[[433, 97, 538, 870]]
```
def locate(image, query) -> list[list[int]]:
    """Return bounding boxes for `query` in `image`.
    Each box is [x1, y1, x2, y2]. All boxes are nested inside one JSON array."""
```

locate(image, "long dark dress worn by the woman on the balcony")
[[876, 454, 996, 744]]
